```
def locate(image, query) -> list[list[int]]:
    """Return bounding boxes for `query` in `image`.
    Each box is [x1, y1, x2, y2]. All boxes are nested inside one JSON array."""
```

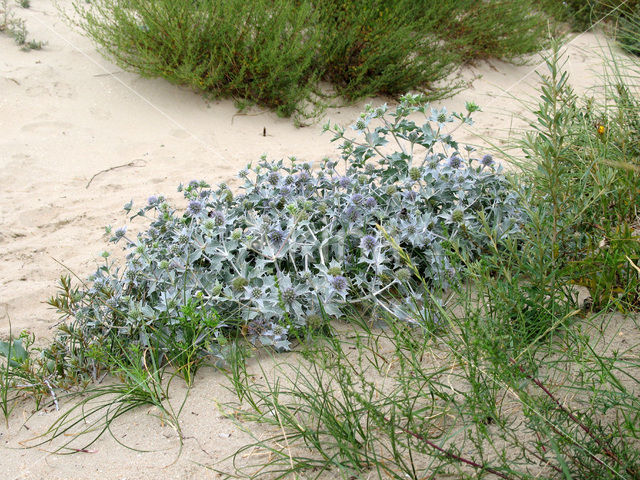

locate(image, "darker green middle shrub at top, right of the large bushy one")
[[314, 0, 459, 100]]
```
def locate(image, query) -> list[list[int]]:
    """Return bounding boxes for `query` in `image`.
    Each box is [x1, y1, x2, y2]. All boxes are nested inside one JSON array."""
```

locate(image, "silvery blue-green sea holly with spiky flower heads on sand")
[[67, 96, 520, 350]]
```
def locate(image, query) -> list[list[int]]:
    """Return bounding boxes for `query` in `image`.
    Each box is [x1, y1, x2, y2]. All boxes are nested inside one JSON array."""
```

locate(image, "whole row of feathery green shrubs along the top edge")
[[67, 0, 548, 116]]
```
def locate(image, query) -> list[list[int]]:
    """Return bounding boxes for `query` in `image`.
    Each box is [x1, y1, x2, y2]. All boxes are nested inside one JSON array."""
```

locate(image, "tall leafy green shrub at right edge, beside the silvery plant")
[[522, 47, 640, 310]]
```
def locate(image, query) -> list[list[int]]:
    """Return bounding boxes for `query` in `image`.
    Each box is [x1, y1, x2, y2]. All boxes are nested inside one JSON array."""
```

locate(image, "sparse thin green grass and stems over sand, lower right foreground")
[[223, 297, 640, 480]]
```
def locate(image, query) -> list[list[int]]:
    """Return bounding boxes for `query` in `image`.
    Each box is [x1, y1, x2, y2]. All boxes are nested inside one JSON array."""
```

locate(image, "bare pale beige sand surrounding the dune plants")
[[0, 0, 636, 479]]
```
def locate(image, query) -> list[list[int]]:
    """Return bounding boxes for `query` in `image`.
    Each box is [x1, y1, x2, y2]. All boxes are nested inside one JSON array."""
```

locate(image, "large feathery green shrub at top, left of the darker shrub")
[[75, 0, 319, 115]]
